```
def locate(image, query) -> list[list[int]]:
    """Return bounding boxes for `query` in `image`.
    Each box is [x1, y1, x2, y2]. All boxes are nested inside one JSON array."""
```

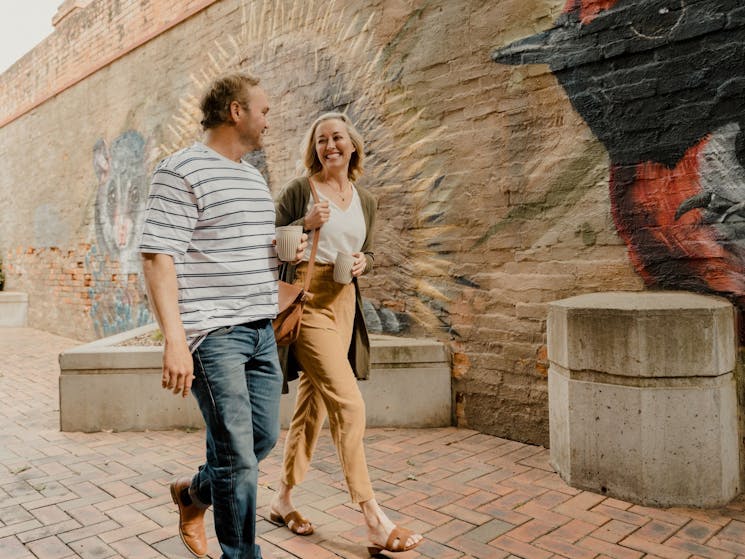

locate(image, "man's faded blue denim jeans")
[[189, 319, 282, 559]]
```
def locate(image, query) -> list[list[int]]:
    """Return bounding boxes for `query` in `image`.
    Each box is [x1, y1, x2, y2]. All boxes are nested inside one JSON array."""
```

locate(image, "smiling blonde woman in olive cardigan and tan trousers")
[[270, 113, 422, 554]]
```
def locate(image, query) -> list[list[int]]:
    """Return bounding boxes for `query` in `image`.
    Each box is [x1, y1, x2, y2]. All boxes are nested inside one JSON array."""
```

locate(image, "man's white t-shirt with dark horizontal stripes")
[[139, 142, 277, 351]]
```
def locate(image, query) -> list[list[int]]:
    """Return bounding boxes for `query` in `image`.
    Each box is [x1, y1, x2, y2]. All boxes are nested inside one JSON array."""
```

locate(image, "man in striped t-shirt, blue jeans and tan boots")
[[139, 73, 307, 559]]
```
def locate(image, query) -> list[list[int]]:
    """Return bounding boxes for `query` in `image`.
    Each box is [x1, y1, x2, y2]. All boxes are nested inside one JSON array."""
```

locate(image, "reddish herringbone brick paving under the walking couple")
[[0, 328, 745, 559]]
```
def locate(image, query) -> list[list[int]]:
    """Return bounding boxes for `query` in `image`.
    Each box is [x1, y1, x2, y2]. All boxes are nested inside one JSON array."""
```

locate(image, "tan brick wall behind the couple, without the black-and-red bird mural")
[[5, 0, 734, 444]]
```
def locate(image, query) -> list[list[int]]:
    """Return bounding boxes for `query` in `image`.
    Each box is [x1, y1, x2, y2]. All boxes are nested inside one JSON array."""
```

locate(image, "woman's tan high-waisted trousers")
[[282, 264, 373, 503]]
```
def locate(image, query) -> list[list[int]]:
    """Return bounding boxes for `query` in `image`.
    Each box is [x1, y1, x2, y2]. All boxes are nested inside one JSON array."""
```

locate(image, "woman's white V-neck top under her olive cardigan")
[[303, 186, 367, 264]]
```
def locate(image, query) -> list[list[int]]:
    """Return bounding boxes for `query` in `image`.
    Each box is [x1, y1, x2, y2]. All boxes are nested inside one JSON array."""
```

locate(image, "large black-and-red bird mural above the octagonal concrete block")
[[492, 0, 745, 324]]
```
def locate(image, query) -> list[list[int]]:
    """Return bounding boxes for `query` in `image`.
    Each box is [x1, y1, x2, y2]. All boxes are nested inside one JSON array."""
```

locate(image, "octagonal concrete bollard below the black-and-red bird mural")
[[547, 292, 740, 507]]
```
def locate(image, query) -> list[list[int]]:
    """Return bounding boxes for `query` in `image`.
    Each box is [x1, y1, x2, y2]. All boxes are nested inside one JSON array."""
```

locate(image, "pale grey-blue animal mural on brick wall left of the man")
[[86, 130, 152, 336]]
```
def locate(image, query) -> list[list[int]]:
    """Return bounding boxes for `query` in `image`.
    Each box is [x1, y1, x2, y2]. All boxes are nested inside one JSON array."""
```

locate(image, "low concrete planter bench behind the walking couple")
[[59, 325, 452, 432]]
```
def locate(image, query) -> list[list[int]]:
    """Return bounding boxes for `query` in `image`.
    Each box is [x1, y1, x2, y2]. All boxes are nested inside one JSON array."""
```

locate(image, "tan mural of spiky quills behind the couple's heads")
[[159, 0, 447, 334]]
